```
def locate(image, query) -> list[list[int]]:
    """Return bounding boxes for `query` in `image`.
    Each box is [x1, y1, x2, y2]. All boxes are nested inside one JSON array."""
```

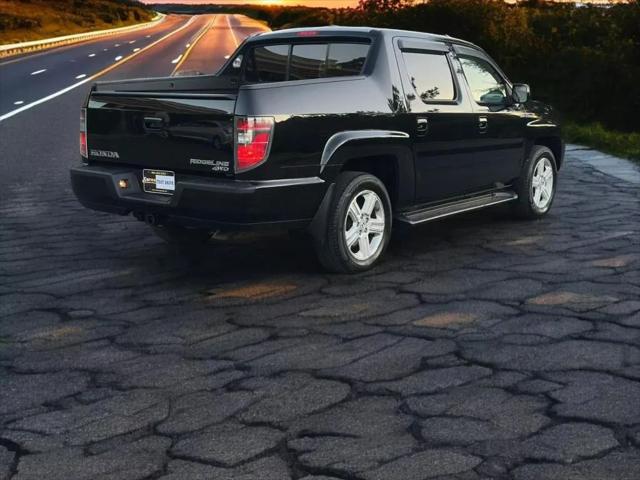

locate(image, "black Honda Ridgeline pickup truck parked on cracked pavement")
[[71, 27, 564, 272]]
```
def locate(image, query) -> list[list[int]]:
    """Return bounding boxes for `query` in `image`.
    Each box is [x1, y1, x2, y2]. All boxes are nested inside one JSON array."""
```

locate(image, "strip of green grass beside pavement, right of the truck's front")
[[563, 123, 640, 162]]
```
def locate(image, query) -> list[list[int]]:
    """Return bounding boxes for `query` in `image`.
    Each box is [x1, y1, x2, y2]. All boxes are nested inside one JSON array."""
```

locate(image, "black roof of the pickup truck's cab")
[[249, 25, 482, 50]]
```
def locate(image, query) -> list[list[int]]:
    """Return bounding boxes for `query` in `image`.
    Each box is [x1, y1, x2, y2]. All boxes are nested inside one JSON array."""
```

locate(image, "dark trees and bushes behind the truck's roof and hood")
[[228, 0, 640, 132]]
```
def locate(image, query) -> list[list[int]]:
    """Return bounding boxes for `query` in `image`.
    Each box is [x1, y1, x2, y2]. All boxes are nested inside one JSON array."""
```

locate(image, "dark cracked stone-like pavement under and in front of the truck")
[[0, 151, 640, 480]]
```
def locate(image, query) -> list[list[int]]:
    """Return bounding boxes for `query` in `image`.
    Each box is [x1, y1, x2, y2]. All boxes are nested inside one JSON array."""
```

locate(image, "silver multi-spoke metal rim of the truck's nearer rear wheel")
[[344, 190, 385, 262]]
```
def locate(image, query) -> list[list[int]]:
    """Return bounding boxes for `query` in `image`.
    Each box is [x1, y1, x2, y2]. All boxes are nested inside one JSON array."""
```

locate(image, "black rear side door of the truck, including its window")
[[395, 38, 477, 204]]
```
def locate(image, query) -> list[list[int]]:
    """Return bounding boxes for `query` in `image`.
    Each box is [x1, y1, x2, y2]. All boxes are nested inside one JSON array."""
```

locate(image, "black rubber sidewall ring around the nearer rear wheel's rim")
[[334, 174, 393, 271]]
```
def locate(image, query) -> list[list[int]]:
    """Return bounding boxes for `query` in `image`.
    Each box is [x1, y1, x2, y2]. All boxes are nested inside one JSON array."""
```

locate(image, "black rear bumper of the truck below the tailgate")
[[71, 165, 327, 228]]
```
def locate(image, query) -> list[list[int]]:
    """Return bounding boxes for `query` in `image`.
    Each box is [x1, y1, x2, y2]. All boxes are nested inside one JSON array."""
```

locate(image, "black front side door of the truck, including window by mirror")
[[455, 46, 527, 187]]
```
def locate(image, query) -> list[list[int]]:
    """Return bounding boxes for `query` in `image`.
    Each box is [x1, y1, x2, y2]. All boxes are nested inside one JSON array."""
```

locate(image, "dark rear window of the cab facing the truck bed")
[[244, 42, 369, 83]]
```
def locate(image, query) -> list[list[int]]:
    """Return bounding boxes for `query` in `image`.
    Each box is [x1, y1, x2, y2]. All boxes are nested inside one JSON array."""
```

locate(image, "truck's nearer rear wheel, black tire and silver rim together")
[[314, 172, 392, 273]]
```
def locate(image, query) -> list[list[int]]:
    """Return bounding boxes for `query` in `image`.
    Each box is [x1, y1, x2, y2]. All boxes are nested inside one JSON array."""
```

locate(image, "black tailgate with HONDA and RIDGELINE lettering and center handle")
[[87, 90, 236, 176]]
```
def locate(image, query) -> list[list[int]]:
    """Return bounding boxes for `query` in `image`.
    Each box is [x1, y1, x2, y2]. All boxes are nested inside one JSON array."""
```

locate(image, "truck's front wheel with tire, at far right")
[[514, 146, 558, 219]]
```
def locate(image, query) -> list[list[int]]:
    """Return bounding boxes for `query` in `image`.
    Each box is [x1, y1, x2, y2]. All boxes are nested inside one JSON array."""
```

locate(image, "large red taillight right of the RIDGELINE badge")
[[236, 117, 274, 172]]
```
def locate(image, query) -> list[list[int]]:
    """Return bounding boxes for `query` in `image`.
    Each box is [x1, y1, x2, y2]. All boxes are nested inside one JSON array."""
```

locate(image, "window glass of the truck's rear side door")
[[402, 52, 455, 102]]
